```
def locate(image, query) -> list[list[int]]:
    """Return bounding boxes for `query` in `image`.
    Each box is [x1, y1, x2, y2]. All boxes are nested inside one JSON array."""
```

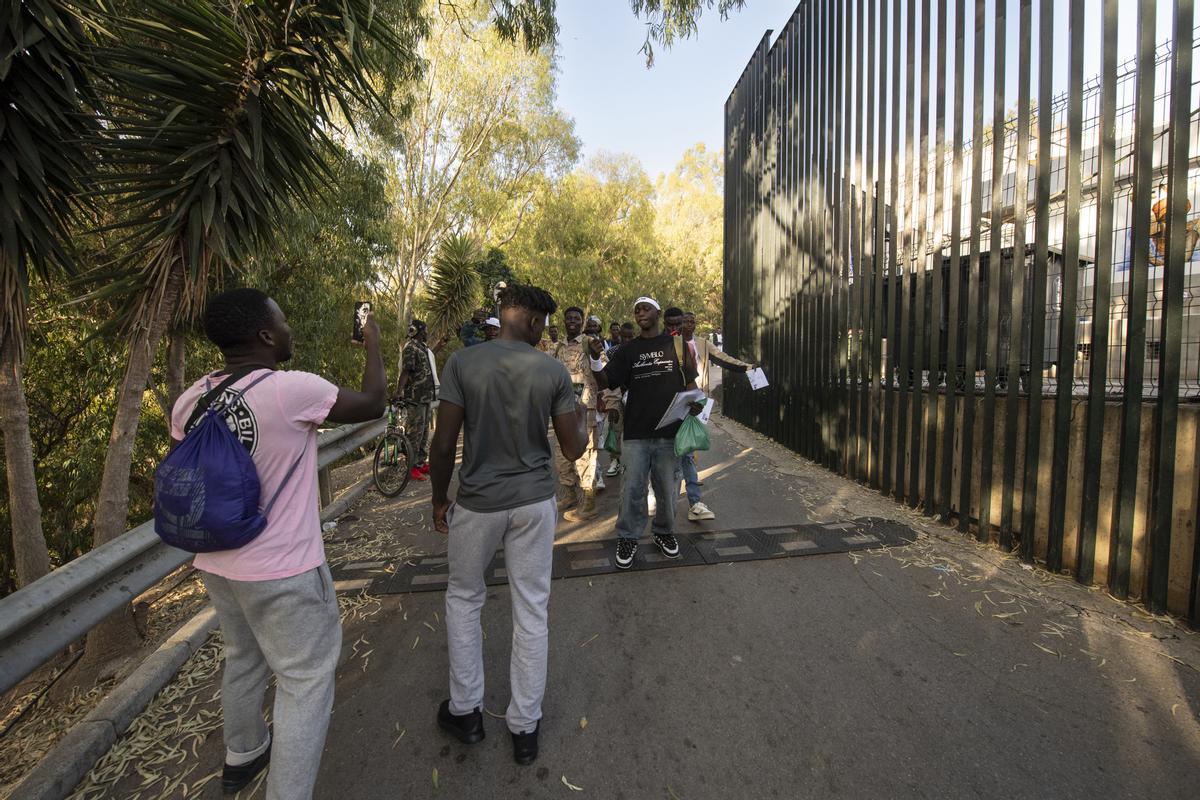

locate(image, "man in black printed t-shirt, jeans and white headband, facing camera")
[[590, 297, 702, 570]]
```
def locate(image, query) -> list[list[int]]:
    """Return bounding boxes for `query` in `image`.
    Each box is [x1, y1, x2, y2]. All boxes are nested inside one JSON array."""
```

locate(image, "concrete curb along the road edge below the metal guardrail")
[[10, 465, 372, 800]]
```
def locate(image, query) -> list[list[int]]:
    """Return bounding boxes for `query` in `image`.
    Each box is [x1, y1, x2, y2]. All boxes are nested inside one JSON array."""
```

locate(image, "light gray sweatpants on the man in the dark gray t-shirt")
[[446, 498, 558, 733]]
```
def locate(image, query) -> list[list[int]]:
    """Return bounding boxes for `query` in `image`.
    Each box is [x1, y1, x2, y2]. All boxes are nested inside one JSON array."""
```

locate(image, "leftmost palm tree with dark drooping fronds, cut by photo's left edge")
[[0, 0, 97, 585]]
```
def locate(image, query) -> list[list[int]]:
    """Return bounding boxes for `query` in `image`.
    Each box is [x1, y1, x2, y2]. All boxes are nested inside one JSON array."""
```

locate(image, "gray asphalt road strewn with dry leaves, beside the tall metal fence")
[[68, 422, 1200, 800]]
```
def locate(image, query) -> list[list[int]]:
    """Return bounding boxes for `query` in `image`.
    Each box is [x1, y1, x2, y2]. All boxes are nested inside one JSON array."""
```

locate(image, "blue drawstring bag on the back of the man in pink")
[[154, 371, 302, 553]]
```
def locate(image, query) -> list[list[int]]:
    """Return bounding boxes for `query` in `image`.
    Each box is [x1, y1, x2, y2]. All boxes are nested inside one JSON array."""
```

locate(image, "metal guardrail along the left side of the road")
[[0, 419, 386, 692]]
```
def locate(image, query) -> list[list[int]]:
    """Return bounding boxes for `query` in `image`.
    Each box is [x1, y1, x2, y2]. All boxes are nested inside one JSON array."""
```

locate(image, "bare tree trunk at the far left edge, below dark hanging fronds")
[[0, 336, 50, 587]]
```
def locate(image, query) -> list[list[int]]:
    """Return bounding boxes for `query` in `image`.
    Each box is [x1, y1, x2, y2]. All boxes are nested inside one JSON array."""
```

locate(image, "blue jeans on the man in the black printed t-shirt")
[[617, 439, 679, 539]]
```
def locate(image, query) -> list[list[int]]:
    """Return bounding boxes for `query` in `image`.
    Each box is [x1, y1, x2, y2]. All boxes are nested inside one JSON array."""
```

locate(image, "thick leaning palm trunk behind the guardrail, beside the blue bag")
[[84, 264, 184, 667]]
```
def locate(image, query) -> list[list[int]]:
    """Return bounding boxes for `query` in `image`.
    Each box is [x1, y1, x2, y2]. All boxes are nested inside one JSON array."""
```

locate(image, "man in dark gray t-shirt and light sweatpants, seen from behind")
[[430, 285, 587, 764]]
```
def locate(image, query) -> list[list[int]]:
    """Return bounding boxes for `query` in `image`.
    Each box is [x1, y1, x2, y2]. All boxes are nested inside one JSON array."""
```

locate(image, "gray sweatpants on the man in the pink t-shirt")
[[200, 564, 342, 800]]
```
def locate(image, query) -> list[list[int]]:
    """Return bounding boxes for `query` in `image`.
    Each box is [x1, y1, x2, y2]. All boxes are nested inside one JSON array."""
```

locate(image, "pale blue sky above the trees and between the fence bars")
[[558, 0, 1172, 176]]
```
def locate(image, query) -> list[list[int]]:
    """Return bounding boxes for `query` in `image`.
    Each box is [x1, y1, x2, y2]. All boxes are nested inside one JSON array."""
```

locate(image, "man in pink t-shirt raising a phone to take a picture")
[[170, 289, 386, 800]]
